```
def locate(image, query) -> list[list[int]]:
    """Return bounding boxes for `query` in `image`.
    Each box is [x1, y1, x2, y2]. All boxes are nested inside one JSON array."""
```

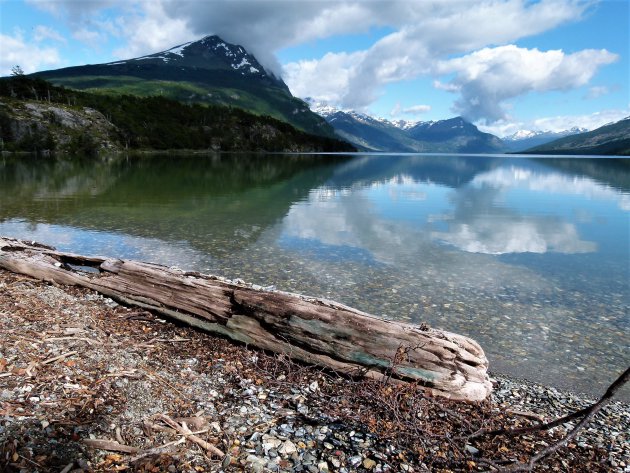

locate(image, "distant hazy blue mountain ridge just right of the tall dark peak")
[[314, 99, 505, 153]]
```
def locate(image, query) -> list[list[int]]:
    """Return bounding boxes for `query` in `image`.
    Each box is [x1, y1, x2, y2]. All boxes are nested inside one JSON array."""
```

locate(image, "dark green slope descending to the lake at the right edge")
[[524, 117, 630, 156]]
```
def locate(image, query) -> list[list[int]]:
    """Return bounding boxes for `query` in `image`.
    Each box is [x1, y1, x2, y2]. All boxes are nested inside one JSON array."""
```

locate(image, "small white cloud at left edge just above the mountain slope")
[[0, 31, 61, 76]]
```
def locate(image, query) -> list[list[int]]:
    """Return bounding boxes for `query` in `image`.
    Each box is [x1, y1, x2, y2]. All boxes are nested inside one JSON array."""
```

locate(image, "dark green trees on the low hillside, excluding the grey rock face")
[[0, 75, 355, 152]]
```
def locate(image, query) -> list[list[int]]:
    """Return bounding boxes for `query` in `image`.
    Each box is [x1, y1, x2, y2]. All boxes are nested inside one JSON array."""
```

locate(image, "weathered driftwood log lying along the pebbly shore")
[[0, 237, 492, 401]]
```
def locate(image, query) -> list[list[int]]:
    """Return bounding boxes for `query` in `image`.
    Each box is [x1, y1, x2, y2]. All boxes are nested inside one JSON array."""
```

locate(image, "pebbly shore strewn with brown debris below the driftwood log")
[[0, 270, 630, 473]]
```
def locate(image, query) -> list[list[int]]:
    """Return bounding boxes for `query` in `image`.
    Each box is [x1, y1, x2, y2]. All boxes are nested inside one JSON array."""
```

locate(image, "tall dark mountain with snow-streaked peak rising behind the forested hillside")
[[34, 36, 334, 137]]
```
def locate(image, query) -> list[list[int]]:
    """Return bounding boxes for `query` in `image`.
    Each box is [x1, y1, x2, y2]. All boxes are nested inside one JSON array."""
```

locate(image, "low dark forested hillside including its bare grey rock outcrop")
[[0, 76, 354, 153]]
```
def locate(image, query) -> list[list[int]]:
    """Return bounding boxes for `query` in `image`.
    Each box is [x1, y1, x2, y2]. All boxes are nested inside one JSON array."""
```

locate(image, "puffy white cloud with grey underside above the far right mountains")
[[436, 45, 618, 122]]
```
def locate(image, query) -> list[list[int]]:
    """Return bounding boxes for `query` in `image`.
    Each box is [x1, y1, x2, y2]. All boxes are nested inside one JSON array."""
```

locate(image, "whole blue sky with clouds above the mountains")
[[0, 0, 630, 136]]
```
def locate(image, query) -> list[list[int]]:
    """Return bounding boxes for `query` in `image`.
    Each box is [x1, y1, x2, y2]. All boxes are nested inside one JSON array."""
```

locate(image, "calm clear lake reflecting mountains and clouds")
[[0, 154, 630, 394]]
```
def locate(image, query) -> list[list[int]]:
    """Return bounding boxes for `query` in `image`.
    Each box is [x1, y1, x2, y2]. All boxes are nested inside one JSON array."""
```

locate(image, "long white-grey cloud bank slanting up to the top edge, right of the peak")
[[285, 0, 588, 109]]
